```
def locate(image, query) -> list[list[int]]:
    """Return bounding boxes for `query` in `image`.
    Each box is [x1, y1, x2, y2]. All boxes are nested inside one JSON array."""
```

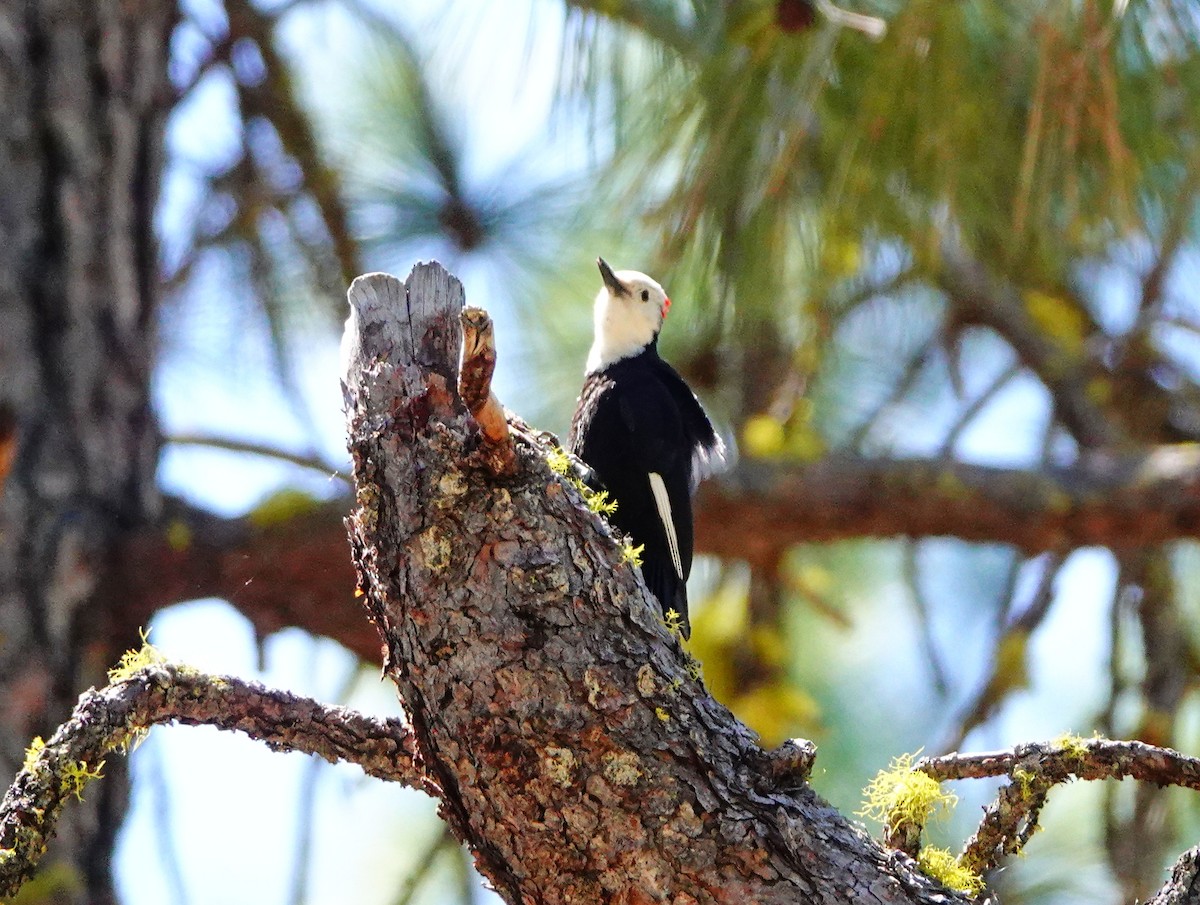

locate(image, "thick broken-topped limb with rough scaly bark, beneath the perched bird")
[[343, 265, 956, 904]]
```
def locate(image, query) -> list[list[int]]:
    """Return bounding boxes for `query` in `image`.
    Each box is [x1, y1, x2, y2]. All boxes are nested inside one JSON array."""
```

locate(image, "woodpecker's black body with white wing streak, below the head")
[[570, 337, 722, 637]]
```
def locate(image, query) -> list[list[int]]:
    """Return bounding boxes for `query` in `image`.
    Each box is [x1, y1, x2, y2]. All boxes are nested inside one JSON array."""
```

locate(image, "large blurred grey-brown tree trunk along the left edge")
[[0, 0, 176, 903]]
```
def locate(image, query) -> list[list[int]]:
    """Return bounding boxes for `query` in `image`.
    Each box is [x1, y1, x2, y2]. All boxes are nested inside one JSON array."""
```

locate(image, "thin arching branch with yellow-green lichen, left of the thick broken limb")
[[0, 663, 437, 899]]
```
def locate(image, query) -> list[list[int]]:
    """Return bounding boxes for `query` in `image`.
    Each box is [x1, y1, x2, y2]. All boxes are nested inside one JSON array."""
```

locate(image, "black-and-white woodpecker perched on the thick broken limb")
[[569, 258, 726, 639]]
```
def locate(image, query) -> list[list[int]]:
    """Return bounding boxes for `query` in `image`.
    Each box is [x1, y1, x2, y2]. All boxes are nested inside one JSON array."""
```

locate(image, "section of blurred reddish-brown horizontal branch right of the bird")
[[696, 444, 1200, 562]]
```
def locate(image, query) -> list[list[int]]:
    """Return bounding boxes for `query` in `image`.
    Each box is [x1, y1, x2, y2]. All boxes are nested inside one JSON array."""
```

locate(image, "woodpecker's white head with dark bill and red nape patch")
[[587, 258, 671, 374]]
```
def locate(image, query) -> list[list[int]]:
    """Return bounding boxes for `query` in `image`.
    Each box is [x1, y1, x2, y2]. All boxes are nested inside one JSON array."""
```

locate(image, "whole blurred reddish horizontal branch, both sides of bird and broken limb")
[[105, 441, 1200, 661]]
